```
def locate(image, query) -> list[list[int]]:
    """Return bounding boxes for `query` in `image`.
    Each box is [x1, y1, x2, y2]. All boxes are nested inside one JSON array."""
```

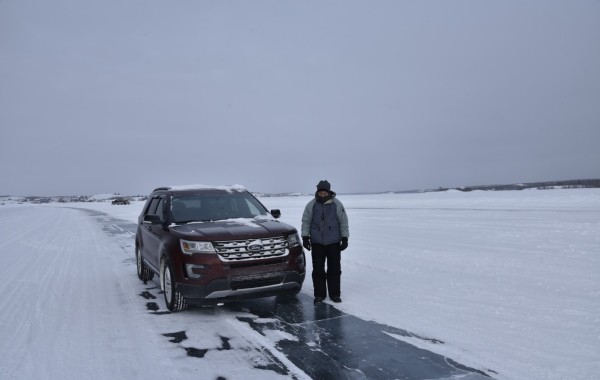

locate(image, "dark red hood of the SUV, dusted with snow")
[[169, 219, 296, 241]]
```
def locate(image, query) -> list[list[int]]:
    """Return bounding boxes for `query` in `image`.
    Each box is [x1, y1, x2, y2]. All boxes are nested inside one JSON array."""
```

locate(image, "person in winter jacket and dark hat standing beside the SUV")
[[302, 180, 349, 304]]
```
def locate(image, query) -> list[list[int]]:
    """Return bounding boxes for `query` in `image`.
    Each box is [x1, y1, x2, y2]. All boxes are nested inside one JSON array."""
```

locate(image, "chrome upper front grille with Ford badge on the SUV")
[[213, 236, 288, 261]]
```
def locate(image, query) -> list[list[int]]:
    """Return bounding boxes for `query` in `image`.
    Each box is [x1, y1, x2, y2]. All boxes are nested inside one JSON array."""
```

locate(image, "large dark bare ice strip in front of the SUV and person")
[[224, 294, 489, 380]]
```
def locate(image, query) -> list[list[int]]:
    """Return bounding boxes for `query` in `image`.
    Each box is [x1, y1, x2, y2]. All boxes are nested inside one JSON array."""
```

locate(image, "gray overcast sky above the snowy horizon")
[[0, 0, 600, 195]]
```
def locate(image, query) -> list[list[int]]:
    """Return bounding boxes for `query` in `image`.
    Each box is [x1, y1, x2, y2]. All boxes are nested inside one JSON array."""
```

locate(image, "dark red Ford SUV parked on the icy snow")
[[135, 185, 306, 311]]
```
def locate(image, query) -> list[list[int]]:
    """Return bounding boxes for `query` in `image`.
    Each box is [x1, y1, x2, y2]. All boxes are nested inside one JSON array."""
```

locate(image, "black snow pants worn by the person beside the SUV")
[[312, 243, 342, 298]]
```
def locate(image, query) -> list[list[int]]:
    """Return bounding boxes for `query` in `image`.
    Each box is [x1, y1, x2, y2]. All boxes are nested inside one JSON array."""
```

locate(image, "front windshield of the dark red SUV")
[[171, 193, 267, 223]]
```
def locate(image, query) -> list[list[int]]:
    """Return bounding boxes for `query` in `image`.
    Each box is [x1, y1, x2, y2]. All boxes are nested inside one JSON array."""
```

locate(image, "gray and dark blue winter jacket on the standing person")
[[302, 196, 350, 245]]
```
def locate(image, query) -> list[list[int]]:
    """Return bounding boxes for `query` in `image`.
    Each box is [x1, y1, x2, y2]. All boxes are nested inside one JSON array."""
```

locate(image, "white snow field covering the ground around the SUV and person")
[[0, 189, 600, 380]]
